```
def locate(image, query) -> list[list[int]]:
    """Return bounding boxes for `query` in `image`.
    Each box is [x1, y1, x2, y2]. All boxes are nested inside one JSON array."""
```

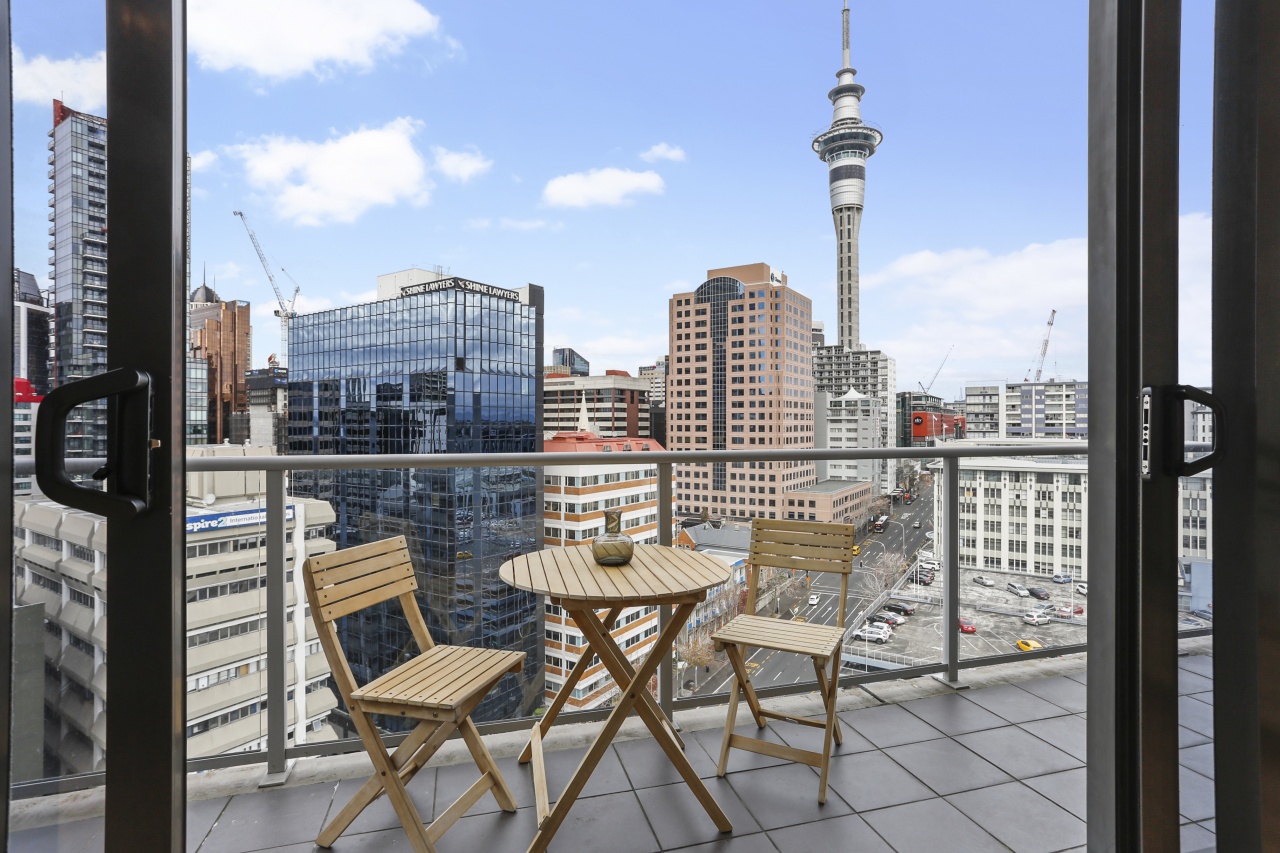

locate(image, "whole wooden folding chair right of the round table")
[[712, 519, 856, 803]]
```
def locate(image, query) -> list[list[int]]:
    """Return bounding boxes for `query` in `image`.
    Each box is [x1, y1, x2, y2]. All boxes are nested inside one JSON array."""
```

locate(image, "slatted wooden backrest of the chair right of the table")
[[746, 519, 858, 626]]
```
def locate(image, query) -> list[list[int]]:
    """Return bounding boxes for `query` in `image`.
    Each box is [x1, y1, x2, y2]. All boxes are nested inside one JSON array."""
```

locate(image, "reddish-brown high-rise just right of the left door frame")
[[188, 284, 253, 444]]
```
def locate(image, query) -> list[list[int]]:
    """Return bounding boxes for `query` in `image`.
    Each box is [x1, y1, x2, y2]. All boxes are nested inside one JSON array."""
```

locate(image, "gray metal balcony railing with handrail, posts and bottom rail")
[[13, 439, 1100, 798]]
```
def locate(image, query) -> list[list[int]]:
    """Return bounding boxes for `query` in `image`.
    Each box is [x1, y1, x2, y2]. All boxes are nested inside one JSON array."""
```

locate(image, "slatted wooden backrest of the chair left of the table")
[[302, 535, 435, 704]]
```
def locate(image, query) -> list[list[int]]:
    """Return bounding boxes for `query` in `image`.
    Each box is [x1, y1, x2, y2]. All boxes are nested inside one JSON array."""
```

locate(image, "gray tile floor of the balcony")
[[9, 656, 1215, 853]]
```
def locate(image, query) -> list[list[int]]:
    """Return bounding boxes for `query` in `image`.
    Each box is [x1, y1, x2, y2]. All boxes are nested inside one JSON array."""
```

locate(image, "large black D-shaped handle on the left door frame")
[[33, 369, 154, 520]]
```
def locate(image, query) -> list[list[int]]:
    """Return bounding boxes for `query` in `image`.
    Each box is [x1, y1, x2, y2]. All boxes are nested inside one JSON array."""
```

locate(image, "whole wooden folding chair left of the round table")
[[303, 537, 525, 853]]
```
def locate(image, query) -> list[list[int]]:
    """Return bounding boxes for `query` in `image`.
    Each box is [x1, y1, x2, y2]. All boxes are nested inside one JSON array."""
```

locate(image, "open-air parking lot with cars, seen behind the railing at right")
[[849, 569, 1089, 663]]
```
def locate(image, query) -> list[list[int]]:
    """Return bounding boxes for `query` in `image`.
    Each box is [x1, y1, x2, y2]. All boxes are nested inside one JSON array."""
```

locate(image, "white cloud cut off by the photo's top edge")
[[187, 0, 442, 81]]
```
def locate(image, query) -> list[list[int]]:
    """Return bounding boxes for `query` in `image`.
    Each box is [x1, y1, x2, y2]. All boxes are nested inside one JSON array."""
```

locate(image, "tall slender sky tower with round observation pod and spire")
[[813, 0, 884, 350]]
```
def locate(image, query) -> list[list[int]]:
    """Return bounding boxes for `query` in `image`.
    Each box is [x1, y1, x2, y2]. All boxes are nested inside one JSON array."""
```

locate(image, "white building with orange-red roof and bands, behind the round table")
[[543, 432, 671, 710]]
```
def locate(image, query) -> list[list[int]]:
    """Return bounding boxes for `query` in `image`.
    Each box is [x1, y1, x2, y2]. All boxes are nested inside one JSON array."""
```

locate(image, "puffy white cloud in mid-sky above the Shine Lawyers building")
[[225, 118, 431, 225]]
